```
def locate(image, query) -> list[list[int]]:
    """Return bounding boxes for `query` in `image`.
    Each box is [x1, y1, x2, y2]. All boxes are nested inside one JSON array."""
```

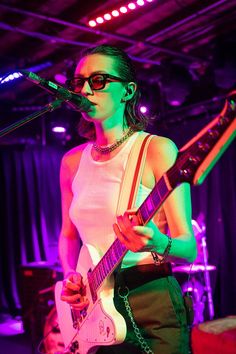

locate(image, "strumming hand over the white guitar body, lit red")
[[61, 272, 89, 310]]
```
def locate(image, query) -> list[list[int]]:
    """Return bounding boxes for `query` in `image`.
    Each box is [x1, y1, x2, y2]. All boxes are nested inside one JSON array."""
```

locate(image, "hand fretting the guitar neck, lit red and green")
[[113, 210, 164, 252]]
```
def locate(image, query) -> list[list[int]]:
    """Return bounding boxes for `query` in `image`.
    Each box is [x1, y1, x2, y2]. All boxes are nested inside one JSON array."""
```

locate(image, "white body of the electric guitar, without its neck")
[[55, 246, 126, 354]]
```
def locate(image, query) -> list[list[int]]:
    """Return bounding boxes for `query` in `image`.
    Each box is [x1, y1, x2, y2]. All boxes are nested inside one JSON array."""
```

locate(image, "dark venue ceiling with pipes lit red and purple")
[[0, 0, 236, 144]]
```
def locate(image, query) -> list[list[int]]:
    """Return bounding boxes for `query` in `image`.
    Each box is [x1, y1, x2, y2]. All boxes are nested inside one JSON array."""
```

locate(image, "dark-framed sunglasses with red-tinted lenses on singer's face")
[[66, 74, 125, 93]]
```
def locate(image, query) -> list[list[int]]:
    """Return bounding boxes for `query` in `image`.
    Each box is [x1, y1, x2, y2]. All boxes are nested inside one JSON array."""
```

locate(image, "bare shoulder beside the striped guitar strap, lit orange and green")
[[147, 135, 178, 177]]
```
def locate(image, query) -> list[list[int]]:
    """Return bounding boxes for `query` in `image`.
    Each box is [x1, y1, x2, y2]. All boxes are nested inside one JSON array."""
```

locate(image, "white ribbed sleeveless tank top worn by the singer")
[[69, 132, 164, 267]]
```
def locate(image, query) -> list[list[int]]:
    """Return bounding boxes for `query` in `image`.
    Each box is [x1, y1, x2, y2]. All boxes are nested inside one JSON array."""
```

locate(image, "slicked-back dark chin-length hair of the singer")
[[78, 44, 148, 140]]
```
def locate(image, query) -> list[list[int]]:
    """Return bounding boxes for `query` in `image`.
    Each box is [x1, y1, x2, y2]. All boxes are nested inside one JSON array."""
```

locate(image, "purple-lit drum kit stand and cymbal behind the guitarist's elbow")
[[173, 218, 216, 324]]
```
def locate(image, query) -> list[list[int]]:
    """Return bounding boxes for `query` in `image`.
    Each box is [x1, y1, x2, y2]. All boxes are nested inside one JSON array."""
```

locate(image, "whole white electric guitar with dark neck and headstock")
[[55, 91, 236, 354]]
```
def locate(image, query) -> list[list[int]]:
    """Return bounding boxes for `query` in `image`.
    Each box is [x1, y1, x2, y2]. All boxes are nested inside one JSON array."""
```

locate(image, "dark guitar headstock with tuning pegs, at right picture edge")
[[166, 91, 236, 188]]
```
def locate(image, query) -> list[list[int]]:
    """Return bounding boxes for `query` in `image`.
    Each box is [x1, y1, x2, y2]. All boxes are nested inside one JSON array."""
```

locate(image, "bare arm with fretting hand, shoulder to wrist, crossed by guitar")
[[149, 137, 197, 262]]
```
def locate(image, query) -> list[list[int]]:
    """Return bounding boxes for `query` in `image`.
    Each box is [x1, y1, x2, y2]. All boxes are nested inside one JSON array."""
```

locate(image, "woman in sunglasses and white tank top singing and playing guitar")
[[59, 45, 196, 354]]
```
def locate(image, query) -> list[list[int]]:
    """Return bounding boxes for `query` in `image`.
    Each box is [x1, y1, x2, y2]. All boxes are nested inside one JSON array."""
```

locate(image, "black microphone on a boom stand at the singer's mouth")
[[20, 70, 92, 112]]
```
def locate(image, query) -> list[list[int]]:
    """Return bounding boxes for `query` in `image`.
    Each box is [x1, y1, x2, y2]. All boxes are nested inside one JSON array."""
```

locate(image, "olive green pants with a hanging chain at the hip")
[[97, 276, 189, 354]]
